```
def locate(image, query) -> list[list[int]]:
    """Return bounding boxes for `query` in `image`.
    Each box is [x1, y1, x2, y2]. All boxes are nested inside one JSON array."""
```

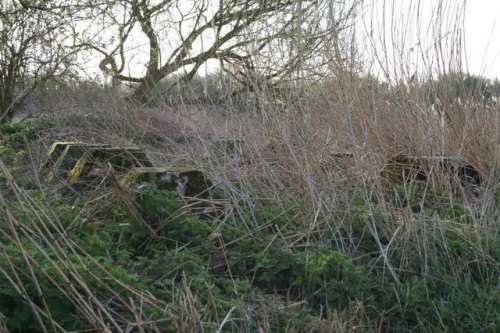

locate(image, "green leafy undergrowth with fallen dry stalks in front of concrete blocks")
[[0, 118, 500, 332]]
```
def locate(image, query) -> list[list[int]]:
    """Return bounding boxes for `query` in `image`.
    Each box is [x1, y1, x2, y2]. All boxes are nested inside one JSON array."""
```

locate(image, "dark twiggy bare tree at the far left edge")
[[0, 0, 81, 123]]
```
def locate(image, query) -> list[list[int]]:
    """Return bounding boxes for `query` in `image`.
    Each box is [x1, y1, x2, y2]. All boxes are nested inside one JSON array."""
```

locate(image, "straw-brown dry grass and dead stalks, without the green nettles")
[[3, 74, 500, 332]]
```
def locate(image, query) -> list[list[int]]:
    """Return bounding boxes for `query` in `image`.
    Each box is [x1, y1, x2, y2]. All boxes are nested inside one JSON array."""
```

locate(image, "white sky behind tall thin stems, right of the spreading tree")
[[357, 0, 500, 83]]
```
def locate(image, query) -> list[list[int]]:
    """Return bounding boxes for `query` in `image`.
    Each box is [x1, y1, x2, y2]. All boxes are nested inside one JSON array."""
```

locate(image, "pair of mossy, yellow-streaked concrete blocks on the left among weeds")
[[40, 142, 212, 198]]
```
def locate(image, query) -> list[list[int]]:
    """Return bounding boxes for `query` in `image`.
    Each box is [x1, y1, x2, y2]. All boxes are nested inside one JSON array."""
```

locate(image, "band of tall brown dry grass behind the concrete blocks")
[[22, 77, 500, 224]]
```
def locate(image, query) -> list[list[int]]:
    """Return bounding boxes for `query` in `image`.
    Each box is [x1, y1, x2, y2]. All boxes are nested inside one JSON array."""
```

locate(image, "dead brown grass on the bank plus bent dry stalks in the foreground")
[[0, 0, 500, 332]]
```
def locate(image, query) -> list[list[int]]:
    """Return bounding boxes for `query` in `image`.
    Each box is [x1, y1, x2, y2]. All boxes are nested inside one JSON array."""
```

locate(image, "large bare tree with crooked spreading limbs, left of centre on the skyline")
[[81, 0, 357, 103]]
